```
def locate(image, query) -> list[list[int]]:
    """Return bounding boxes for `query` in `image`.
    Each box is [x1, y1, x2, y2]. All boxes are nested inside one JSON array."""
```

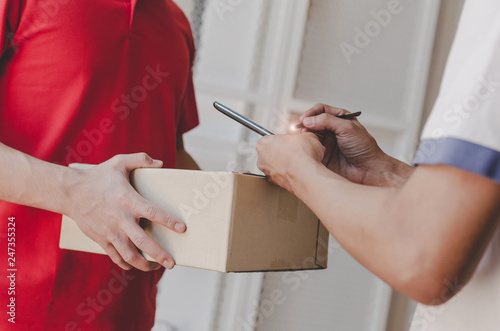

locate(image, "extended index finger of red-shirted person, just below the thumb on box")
[[132, 194, 186, 233]]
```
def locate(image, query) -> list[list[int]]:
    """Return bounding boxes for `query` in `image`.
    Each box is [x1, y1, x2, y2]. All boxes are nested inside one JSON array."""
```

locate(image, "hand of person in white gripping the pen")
[[300, 104, 393, 184]]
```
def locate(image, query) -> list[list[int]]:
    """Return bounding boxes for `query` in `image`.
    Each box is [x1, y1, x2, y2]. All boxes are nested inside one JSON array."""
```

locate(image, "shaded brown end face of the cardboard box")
[[228, 175, 326, 271]]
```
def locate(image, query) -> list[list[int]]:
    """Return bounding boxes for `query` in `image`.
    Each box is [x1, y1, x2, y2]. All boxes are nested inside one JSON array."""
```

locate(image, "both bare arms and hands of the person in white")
[[257, 105, 500, 305]]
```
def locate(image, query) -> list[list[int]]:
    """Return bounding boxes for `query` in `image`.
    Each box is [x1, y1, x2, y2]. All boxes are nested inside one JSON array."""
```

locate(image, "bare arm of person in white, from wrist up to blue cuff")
[[291, 161, 500, 303]]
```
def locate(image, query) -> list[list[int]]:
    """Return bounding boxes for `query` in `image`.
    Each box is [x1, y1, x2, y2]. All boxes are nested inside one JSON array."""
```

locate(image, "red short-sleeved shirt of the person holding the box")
[[0, 0, 198, 330]]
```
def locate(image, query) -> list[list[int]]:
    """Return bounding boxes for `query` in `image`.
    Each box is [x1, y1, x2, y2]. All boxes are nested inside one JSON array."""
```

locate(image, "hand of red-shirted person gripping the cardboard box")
[[65, 153, 186, 271]]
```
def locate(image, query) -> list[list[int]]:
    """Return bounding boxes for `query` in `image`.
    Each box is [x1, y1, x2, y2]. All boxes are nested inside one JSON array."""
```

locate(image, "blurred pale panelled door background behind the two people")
[[154, 0, 464, 331]]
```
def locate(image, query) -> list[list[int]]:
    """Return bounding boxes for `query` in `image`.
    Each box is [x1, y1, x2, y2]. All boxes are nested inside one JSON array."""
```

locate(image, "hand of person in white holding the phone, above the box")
[[257, 133, 325, 193]]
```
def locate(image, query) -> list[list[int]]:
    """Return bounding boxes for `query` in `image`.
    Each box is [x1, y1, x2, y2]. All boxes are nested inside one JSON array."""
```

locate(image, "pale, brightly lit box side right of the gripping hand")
[[131, 169, 234, 271]]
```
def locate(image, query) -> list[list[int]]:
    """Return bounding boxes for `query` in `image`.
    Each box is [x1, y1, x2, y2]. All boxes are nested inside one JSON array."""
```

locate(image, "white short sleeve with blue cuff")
[[414, 0, 500, 182]]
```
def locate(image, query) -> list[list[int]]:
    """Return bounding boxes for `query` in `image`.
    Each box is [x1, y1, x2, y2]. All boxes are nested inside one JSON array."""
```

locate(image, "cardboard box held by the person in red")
[[60, 169, 329, 272]]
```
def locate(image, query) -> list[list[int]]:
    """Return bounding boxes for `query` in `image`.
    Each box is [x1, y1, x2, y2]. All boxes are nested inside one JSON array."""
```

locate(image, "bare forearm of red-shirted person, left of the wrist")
[[0, 143, 75, 213]]
